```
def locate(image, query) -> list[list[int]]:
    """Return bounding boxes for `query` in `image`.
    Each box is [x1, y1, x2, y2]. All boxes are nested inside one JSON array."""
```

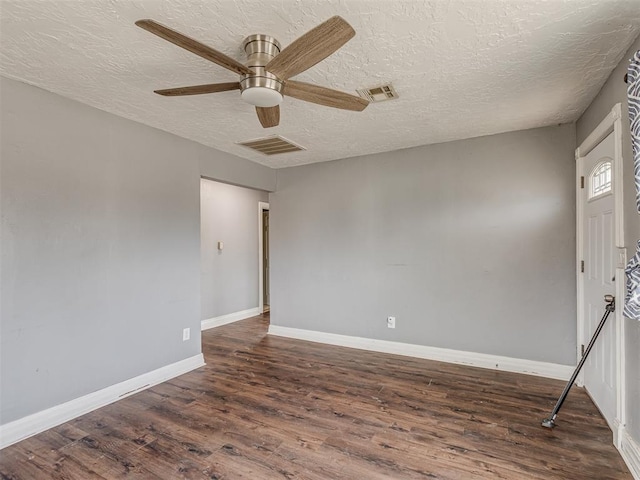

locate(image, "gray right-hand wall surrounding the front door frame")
[[576, 37, 640, 442]]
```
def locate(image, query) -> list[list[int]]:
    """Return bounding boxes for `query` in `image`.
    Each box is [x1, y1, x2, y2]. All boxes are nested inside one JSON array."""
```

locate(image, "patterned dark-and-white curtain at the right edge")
[[624, 50, 640, 320]]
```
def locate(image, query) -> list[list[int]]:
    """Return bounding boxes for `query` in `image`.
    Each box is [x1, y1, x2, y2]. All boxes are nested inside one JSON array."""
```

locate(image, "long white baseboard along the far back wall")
[[269, 325, 574, 380]]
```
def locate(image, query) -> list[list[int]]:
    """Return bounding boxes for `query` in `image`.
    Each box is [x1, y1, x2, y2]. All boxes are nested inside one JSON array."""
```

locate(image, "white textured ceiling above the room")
[[0, 0, 640, 167]]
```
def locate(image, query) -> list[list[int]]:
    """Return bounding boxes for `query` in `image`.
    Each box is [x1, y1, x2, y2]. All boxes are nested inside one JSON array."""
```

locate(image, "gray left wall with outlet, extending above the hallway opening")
[[0, 78, 275, 424]]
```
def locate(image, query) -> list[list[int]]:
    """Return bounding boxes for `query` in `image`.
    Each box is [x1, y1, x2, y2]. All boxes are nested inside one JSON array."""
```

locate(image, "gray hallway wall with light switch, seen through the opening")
[[200, 179, 269, 319]]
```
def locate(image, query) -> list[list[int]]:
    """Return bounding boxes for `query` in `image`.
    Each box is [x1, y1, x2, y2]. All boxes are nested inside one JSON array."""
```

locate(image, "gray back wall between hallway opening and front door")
[[270, 125, 576, 365]]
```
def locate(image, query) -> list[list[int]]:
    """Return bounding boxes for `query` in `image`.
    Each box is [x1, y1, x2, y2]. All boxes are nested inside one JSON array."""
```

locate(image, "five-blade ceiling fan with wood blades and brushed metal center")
[[136, 16, 369, 128]]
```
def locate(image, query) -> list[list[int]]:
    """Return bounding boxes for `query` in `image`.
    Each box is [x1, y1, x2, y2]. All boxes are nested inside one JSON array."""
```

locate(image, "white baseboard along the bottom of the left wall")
[[0, 353, 205, 449]]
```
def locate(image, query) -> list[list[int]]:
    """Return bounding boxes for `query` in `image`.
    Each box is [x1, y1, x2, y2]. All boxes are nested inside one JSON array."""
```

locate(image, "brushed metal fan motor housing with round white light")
[[240, 34, 283, 107]]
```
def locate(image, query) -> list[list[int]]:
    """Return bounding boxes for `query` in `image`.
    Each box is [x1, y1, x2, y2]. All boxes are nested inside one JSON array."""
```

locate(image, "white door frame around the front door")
[[575, 103, 626, 448]]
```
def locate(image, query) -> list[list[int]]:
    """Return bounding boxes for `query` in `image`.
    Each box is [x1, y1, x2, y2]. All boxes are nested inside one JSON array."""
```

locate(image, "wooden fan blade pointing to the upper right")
[[265, 15, 356, 80]]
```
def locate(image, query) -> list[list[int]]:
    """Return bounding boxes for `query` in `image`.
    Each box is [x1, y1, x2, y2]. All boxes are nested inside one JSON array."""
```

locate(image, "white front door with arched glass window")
[[580, 133, 620, 428]]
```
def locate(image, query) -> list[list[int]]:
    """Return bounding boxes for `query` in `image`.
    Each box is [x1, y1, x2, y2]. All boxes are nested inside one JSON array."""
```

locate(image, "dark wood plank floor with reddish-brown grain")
[[0, 317, 631, 480]]
